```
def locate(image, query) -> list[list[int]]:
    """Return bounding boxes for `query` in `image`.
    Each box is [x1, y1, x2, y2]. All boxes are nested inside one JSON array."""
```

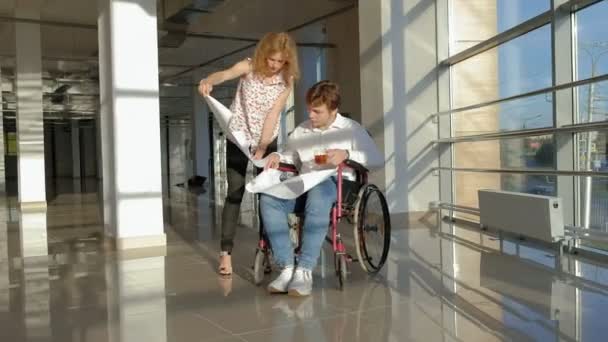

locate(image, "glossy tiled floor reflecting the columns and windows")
[[0, 180, 608, 342]]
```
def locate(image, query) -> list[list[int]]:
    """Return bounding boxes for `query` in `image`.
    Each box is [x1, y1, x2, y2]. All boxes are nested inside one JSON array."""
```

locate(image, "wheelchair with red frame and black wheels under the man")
[[253, 160, 391, 289]]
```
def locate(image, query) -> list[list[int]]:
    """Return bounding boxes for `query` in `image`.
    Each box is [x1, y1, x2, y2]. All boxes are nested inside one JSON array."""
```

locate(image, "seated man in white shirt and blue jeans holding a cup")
[[260, 81, 384, 296]]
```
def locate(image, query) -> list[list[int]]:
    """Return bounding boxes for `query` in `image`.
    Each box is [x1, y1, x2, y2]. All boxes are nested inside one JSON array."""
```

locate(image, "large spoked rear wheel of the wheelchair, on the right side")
[[353, 184, 391, 273]]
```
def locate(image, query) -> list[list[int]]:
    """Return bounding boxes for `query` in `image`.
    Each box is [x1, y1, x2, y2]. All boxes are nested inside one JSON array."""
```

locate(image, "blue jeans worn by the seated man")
[[260, 177, 337, 270]]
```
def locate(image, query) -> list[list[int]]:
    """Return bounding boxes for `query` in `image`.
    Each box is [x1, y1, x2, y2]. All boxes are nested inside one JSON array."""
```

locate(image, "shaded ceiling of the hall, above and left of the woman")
[[0, 0, 356, 114]]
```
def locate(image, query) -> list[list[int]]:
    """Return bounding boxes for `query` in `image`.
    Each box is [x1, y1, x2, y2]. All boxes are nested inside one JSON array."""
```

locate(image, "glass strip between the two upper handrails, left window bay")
[[452, 93, 553, 137]]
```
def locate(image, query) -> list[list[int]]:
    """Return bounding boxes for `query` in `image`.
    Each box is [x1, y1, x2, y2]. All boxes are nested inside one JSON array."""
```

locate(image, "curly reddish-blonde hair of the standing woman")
[[252, 32, 300, 80]]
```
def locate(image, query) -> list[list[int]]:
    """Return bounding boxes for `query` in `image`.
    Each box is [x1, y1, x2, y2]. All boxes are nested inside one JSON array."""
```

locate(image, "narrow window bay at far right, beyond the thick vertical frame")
[[573, 1, 608, 250]]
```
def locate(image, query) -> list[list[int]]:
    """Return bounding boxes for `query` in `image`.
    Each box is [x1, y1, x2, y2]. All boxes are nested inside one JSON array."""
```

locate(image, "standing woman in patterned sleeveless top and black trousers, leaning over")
[[198, 32, 300, 275]]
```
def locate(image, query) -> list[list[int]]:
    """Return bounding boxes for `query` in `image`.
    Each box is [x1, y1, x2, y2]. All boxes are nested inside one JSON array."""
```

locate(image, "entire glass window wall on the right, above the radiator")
[[442, 0, 608, 251]]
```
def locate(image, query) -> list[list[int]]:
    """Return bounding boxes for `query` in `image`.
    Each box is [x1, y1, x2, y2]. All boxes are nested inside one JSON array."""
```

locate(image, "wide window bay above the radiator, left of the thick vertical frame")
[[450, 6, 557, 222]]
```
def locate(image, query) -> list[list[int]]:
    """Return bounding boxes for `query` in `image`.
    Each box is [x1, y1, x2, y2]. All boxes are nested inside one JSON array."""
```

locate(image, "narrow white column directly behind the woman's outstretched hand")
[[190, 72, 211, 179]]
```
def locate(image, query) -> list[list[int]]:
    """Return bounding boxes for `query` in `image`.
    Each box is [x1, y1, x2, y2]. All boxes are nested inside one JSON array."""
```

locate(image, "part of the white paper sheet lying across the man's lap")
[[245, 169, 337, 199]]
